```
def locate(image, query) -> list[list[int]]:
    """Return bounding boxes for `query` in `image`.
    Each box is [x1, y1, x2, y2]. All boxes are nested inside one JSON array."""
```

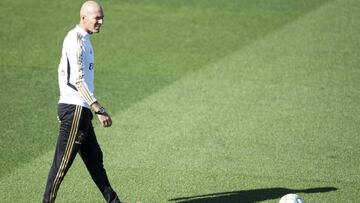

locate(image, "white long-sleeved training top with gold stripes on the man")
[[58, 25, 96, 108]]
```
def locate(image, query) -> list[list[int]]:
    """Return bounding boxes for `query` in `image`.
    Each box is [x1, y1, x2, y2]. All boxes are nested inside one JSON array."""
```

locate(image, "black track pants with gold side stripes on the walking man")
[[43, 104, 120, 203]]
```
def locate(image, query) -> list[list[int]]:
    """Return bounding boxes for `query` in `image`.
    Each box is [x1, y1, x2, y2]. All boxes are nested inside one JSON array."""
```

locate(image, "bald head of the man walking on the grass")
[[80, 1, 104, 34]]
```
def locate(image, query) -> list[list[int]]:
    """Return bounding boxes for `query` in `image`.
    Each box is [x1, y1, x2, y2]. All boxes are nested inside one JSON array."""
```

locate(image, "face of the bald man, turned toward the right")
[[84, 8, 104, 34]]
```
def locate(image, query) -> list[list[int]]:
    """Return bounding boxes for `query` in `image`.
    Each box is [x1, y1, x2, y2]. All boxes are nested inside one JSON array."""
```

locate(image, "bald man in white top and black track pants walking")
[[43, 1, 121, 203]]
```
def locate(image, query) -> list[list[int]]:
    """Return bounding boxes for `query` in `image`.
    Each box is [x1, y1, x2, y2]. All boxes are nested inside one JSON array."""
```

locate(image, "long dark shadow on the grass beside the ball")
[[169, 187, 338, 203]]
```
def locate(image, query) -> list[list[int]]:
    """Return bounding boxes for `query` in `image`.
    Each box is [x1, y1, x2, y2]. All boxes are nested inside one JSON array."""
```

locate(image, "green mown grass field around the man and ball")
[[0, 0, 360, 203]]
